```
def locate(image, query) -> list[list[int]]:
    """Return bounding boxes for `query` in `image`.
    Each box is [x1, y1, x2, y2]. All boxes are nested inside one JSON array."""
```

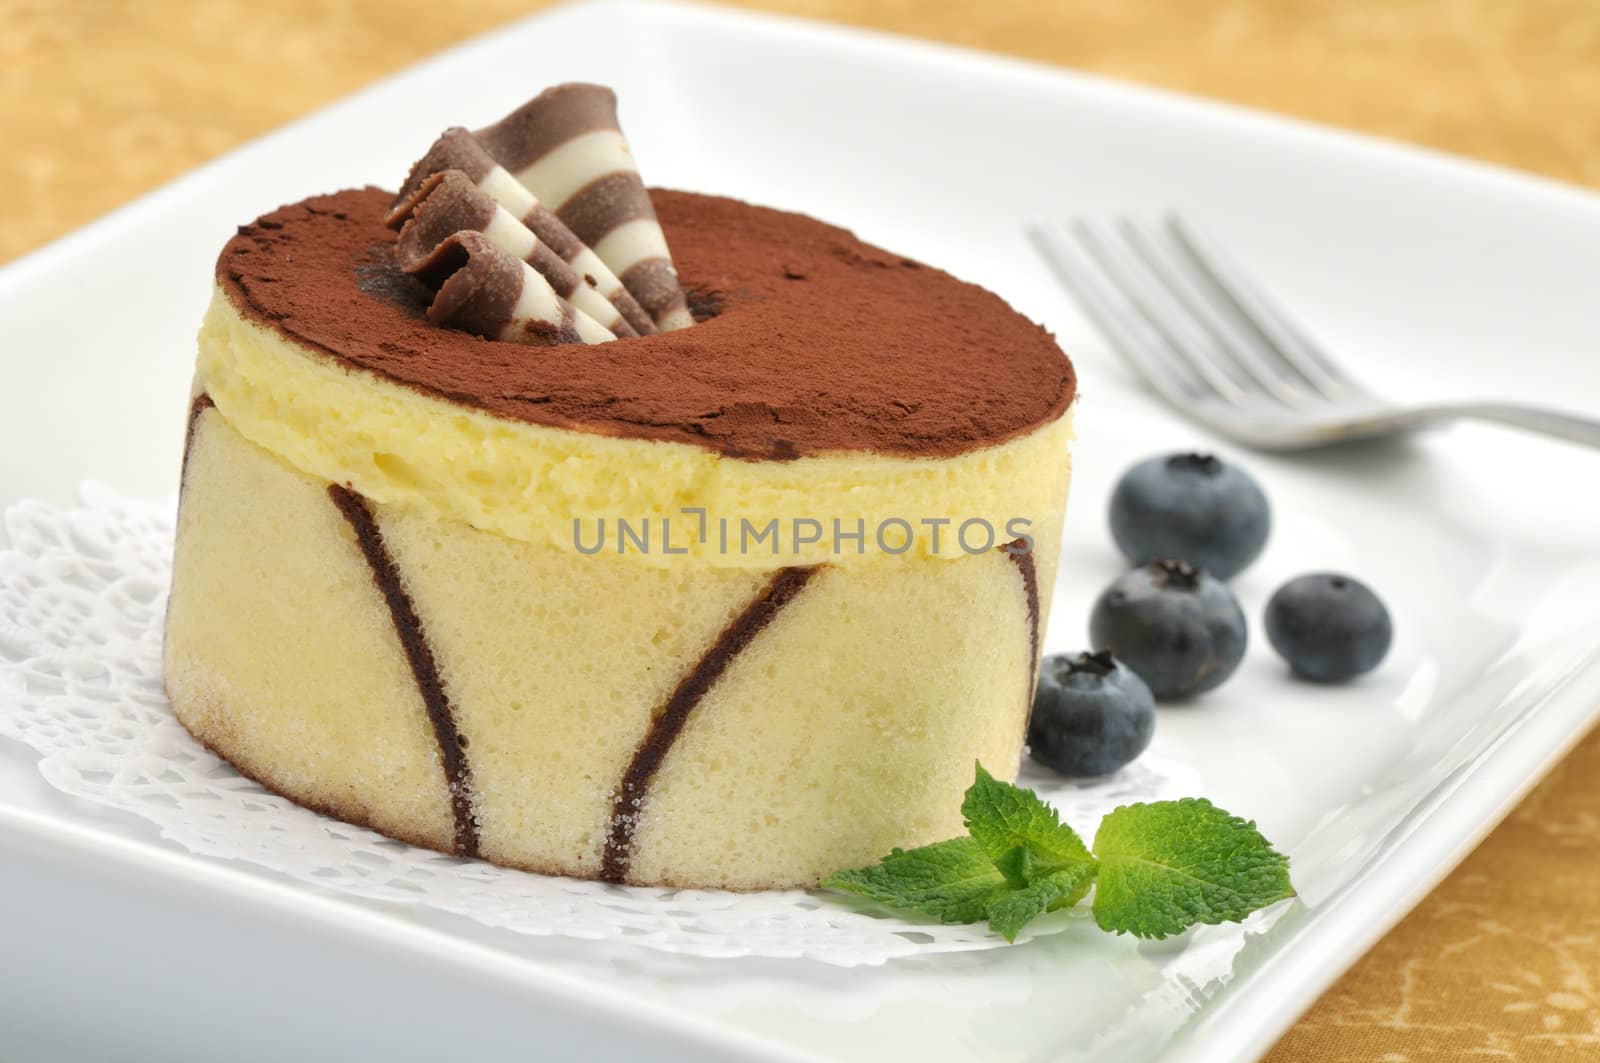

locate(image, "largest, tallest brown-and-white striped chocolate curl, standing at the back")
[[474, 83, 694, 330]]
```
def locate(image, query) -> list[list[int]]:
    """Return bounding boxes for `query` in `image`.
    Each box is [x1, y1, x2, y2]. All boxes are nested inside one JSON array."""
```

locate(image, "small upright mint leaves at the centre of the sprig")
[[962, 764, 1094, 902]]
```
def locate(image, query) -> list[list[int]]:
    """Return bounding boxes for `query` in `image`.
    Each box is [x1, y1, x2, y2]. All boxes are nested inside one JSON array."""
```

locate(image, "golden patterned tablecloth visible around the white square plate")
[[0, 0, 1600, 1063]]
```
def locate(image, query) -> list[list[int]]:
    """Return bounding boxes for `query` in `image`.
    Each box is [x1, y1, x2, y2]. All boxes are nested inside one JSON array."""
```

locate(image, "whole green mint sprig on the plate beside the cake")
[[822, 764, 1294, 941]]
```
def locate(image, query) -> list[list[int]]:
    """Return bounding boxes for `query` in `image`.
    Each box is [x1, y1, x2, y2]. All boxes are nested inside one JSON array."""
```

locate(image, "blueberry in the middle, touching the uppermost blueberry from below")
[[1090, 560, 1248, 700]]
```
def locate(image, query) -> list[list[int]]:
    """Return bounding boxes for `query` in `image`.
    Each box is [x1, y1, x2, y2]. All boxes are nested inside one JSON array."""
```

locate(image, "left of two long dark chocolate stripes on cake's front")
[[328, 483, 478, 856]]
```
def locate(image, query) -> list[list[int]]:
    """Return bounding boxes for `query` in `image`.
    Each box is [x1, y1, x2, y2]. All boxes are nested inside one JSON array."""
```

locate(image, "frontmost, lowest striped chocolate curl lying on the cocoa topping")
[[408, 231, 616, 346]]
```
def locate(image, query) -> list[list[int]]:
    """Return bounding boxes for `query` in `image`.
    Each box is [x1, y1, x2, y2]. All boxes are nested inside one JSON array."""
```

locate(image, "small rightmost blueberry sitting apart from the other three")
[[1266, 572, 1395, 684]]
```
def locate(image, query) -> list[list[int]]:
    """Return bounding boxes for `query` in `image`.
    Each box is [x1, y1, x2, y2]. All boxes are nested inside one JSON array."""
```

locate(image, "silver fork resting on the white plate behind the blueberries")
[[1027, 215, 1600, 450]]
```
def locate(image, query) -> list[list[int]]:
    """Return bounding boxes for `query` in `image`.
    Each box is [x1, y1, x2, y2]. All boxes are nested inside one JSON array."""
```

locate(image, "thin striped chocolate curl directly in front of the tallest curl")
[[384, 126, 658, 336]]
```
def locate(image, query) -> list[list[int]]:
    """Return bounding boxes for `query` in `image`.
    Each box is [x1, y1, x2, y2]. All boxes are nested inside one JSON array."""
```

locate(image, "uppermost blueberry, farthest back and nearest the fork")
[[1110, 455, 1272, 580]]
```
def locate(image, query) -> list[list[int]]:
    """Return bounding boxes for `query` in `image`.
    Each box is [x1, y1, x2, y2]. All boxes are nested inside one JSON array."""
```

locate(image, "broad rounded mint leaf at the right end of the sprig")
[[1094, 797, 1294, 938]]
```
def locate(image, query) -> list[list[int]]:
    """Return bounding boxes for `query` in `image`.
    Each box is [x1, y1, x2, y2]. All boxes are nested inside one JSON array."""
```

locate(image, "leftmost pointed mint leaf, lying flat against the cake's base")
[[822, 837, 1027, 937]]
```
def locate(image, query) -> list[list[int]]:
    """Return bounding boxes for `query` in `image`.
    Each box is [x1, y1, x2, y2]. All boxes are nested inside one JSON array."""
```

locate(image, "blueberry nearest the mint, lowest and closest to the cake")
[[1027, 653, 1155, 778]]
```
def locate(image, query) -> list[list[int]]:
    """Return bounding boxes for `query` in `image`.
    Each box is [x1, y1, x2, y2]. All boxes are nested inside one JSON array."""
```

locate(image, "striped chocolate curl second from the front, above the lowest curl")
[[395, 170, 638, 336]]
